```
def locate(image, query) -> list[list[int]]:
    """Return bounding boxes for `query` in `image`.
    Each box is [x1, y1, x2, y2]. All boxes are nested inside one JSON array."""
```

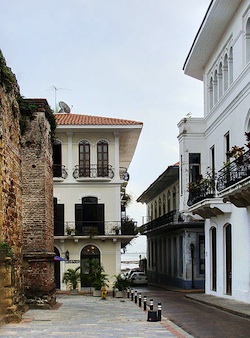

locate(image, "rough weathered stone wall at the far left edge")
[[0, 54, 24, 320]]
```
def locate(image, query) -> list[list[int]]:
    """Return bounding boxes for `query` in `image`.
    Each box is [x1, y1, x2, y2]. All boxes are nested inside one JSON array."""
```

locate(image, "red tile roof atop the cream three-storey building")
[[55, 114, 143, 126]]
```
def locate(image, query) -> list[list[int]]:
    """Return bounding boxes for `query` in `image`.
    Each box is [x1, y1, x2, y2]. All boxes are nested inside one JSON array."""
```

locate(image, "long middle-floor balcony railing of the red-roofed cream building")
[[54, 221, 137, 236]]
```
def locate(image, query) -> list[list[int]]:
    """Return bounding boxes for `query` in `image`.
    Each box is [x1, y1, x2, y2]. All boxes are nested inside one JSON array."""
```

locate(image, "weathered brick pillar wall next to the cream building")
[[22, 99, 55, 307]]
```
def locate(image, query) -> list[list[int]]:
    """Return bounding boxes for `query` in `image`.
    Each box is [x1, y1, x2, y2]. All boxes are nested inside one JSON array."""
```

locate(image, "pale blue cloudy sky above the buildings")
[[0, 0, 210, 251]]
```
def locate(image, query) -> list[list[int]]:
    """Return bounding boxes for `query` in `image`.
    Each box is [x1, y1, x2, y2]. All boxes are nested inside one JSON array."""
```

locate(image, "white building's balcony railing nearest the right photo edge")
[[216, 150, 250, 191]]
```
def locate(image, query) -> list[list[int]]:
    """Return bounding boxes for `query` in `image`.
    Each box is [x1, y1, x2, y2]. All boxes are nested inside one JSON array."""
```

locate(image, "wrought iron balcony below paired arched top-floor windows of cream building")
[[73, 164, 114, 179]]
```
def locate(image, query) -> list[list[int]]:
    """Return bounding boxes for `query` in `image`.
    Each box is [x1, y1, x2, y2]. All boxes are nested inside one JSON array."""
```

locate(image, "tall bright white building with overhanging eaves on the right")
[[178, 0, 250, 303]]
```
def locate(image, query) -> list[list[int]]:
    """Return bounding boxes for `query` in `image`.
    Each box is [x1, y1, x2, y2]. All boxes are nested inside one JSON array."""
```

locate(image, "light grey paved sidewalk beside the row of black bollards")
[[0, 295, 191, 338]]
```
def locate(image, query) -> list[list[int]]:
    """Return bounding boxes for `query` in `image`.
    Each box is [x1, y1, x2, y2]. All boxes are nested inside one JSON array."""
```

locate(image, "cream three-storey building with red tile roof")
[[53, 113, 142, 289]]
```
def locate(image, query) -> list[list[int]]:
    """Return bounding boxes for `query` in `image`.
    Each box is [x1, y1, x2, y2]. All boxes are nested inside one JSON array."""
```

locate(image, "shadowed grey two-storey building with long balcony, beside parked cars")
[[137, 163, 205, 289]]
